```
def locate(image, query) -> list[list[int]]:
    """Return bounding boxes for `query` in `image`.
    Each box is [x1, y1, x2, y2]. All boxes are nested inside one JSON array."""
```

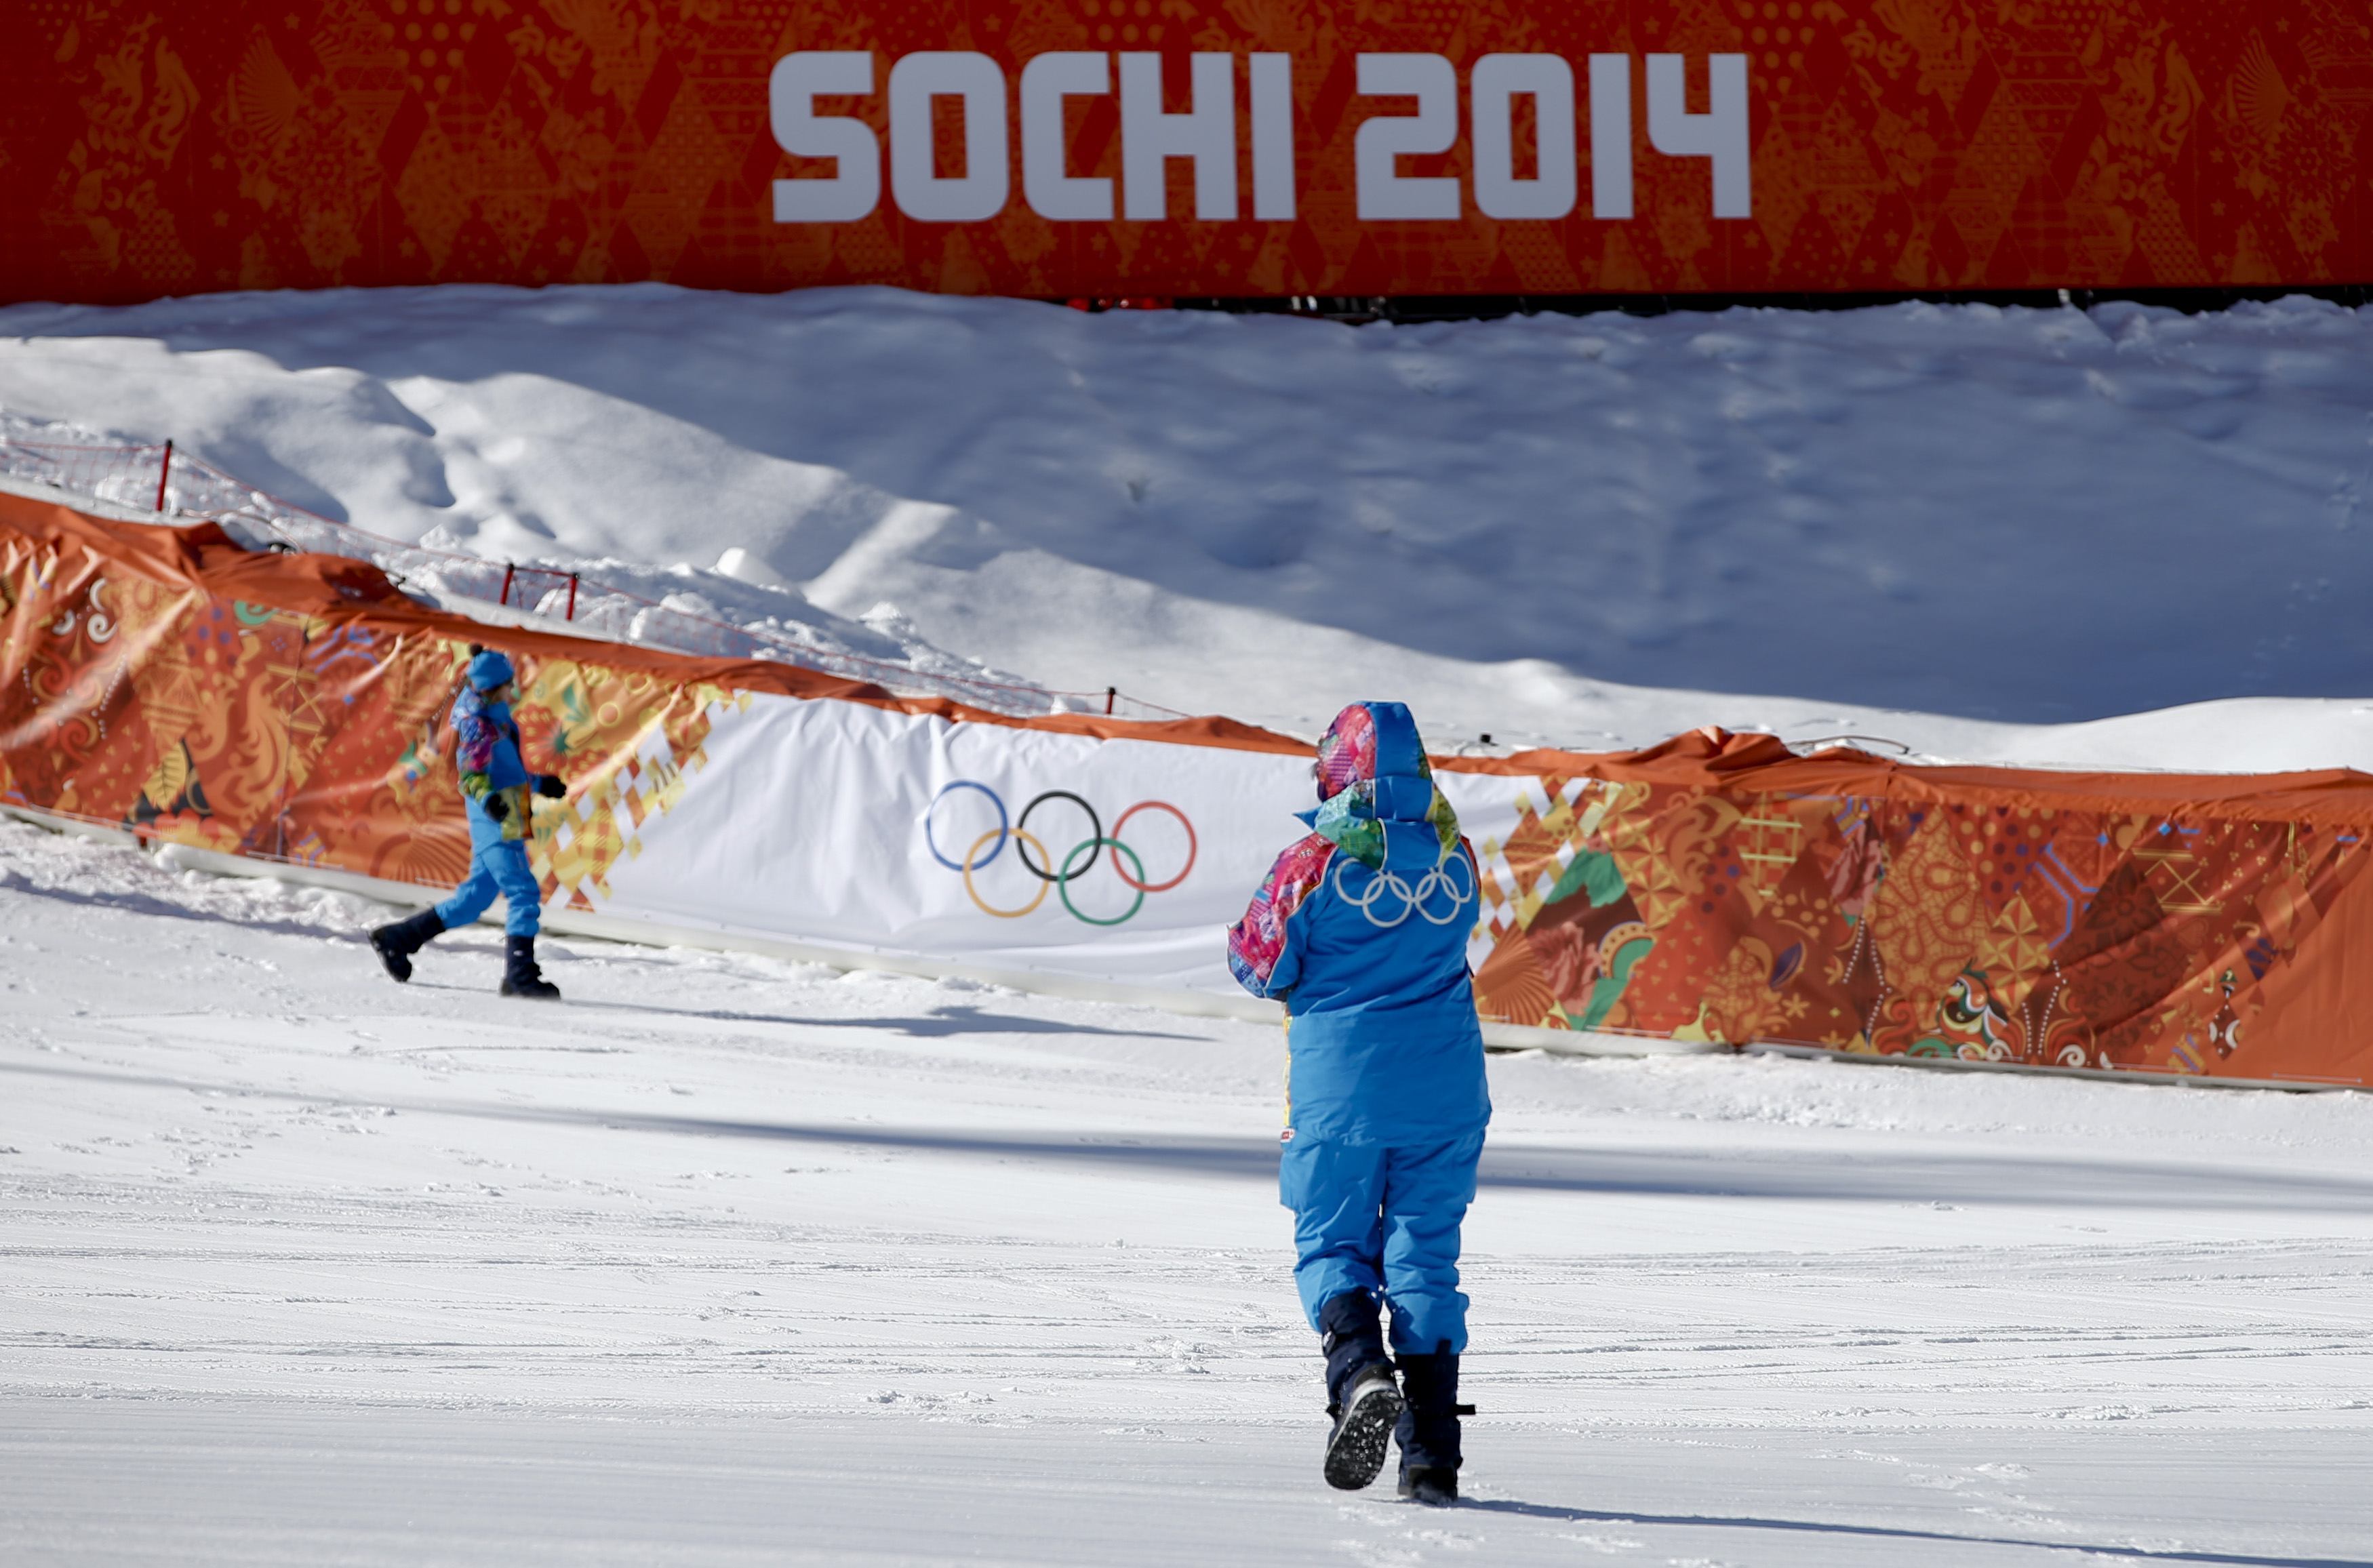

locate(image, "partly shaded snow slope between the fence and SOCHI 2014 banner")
[[0, 287, 2373, 769]]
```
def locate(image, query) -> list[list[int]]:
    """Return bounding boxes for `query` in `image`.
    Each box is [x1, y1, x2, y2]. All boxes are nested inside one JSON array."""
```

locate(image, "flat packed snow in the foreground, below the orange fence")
[[0, 823, 2373, 1568]]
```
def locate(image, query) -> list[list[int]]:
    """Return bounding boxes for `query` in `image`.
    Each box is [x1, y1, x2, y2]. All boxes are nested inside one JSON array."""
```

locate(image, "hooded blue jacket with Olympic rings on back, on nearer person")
[[1229, 702, 1490, 1146]]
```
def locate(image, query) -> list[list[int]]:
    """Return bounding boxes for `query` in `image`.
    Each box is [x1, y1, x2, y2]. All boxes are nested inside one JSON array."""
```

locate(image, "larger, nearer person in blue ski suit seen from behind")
[[1229, 702, 1490, 1504]]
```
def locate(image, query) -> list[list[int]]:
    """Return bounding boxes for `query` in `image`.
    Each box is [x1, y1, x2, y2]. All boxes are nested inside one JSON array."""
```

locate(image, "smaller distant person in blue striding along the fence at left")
[[370, 647, 567, 1001]]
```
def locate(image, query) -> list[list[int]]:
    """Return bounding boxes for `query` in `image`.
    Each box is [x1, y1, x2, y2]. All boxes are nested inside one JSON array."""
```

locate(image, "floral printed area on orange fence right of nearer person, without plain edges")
[[1471, 776, 2366, 1077]]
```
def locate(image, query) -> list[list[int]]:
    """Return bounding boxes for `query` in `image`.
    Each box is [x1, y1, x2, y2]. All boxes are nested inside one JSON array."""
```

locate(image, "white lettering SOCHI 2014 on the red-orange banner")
[[767, 49, 1754, 223]]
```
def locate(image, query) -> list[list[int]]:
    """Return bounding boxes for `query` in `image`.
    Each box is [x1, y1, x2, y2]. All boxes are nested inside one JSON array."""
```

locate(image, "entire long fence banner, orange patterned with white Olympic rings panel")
[[0, 494, 2373, 1087]]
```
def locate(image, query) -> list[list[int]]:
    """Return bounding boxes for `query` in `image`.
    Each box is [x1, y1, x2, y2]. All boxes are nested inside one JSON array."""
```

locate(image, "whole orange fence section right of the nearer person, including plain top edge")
[[1443, 731, 2373, 1084]]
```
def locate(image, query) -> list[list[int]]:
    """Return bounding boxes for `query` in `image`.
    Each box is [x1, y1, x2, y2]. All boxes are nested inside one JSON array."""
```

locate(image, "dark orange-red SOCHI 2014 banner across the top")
[[0, 0, 2373, 301]]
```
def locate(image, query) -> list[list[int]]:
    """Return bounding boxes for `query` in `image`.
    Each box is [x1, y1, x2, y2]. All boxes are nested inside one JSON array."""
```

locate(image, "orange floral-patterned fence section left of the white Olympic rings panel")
[[0, 519, 721, 908]]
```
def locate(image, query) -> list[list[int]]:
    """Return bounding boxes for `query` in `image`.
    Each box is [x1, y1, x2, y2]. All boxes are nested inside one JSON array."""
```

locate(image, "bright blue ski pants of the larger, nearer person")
[[1277, 1131, 1483, 1354]]
